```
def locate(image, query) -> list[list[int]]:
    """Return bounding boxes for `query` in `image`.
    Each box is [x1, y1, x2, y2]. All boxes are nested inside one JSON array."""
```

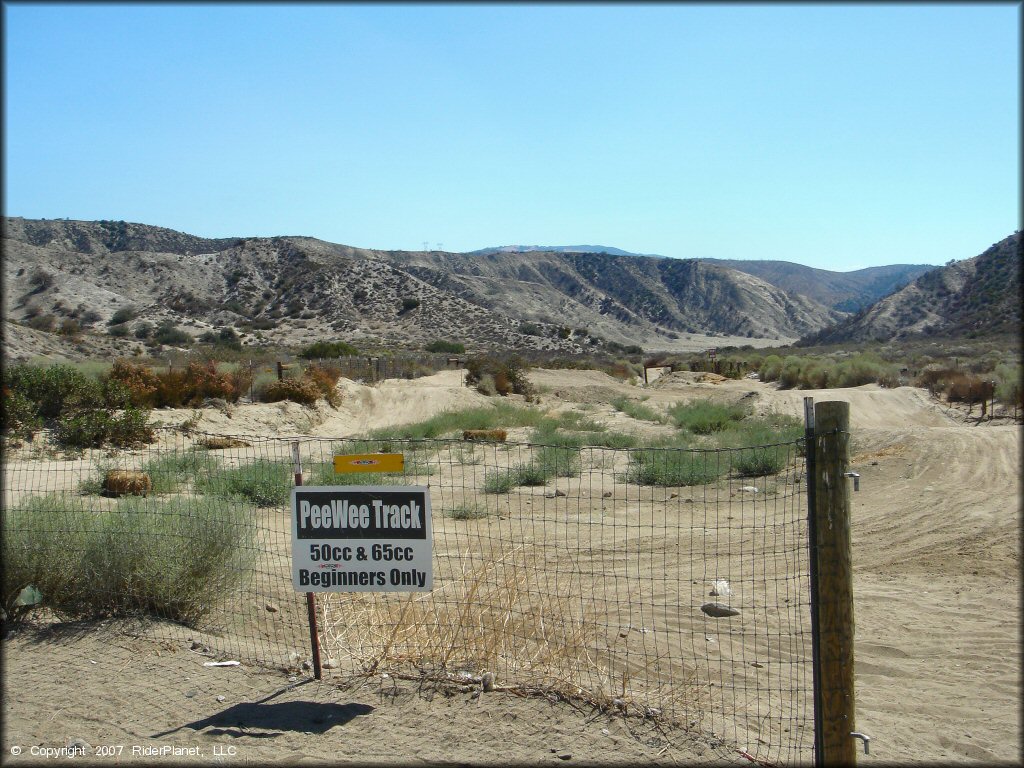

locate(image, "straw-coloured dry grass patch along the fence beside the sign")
[[319, 545, 708, 720]]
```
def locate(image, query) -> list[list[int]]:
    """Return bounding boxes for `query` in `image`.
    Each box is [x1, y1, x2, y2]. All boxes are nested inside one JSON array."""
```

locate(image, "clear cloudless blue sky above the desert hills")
[[3, 2, 1021, 270]]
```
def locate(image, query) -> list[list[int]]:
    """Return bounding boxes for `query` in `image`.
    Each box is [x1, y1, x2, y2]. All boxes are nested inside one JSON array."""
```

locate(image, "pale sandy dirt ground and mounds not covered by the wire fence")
[[2, 371, 1022, 765]]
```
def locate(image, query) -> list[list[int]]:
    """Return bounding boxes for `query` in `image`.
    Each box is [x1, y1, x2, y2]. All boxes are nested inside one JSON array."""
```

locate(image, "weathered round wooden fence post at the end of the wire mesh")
[[812, 400, 858, 766]]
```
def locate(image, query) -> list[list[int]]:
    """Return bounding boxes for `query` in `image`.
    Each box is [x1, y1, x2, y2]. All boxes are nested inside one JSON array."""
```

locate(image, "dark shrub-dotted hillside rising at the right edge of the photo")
[[800, 231, 1021, 344]]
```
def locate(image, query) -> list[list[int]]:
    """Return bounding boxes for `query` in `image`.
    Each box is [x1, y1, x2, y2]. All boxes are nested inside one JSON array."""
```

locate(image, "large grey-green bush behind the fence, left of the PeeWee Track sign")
[[3, 495, 252, 626]]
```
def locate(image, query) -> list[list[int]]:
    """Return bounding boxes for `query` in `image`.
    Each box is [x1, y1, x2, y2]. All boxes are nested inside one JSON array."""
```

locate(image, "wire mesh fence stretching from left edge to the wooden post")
[[3, 430, 813, 763]]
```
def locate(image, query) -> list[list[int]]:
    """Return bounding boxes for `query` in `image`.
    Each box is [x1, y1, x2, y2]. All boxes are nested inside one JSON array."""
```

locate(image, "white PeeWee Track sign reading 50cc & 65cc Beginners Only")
[[292, 485, 433, 592]]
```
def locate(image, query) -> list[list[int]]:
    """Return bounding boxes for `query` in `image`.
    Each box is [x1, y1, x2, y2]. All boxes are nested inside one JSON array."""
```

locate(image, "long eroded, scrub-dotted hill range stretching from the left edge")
[[3, 218, 842, 360]]
